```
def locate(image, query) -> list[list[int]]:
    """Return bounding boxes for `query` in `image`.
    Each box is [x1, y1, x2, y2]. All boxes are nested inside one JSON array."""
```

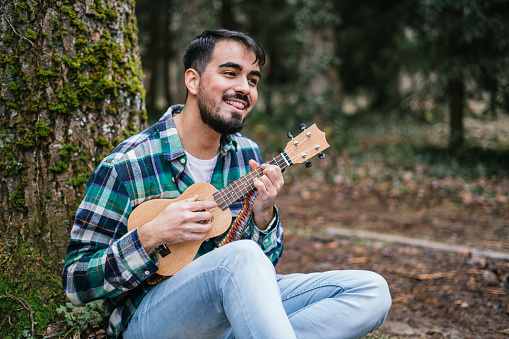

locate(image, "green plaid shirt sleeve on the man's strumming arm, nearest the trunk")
[[62, 161, 158, 305]]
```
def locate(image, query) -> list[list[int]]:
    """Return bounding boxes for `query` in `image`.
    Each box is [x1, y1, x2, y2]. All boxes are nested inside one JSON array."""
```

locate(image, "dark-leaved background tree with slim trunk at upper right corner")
[[396, 0, 509, 151]]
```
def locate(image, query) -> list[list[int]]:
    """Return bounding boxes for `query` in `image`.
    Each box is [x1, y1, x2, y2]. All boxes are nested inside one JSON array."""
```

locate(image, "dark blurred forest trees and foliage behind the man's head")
[[137, 0, 509, 152]]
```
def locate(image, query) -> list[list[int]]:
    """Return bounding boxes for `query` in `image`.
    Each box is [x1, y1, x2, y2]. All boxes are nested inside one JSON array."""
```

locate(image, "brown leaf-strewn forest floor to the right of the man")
[[42, 148, 509, 339]]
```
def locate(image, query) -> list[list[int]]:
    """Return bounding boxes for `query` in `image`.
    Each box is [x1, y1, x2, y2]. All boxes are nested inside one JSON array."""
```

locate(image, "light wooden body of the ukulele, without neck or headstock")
[[127, 182, 232, 276]]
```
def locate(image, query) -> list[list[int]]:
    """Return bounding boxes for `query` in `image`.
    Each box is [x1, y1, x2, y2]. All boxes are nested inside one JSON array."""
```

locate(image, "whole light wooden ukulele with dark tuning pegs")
[[127, 124, 329, 276]]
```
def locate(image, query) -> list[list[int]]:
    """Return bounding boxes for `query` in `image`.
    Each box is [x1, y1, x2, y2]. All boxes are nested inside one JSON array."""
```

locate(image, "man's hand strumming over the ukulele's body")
[[138, 195, 217, 253]]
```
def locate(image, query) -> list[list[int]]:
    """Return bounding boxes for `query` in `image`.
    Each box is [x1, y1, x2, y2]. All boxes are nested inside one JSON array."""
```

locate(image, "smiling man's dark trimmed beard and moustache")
[[197, 84, 250, 134]]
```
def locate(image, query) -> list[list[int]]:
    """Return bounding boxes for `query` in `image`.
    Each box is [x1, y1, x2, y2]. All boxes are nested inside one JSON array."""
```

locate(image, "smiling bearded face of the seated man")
[[193, 41, 261, 134]]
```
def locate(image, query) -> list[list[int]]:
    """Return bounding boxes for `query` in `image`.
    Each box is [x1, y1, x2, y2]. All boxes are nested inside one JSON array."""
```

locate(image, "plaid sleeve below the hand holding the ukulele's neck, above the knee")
[[243, 206, 283, 266]]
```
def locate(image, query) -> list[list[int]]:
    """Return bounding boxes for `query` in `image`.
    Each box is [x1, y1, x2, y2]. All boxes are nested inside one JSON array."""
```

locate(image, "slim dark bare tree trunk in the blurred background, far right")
[[449, 79, 465, 152]]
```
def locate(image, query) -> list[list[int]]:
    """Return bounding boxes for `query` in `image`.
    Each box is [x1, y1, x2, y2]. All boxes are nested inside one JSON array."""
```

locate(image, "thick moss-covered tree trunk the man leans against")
[[0, 0, 146, 262]]
